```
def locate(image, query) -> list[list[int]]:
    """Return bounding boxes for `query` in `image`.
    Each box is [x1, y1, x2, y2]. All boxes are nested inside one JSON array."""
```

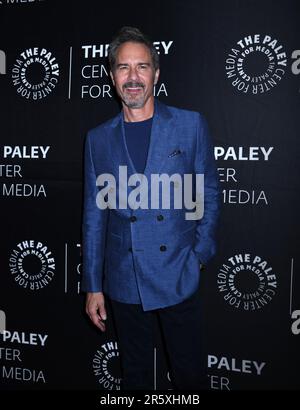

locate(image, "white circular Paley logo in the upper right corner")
[[225, 34, 287, 95]]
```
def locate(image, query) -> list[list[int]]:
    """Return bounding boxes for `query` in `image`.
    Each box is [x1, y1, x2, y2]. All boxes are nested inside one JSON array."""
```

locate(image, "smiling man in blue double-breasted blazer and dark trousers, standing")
[[82, 27, 219, 390]]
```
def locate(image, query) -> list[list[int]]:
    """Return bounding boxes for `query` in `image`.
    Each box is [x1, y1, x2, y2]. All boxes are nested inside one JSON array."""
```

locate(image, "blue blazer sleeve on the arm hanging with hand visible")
[[81, 133, 109, 292]]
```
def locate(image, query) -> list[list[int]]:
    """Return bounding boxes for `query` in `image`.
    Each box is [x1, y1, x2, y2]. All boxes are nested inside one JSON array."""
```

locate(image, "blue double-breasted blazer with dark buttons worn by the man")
[[81, 100, 220, 311]]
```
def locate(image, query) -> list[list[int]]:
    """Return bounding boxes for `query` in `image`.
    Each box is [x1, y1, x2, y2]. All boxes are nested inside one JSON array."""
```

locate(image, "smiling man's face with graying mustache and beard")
[[110, 42, 159, 108]]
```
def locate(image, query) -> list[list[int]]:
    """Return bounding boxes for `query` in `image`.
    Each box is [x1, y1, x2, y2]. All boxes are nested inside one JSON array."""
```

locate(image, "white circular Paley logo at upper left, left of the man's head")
[[12, 47, 59, 100]]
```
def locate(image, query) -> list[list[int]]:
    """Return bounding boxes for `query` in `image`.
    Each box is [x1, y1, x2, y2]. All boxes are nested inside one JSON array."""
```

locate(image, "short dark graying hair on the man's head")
[[108, 26, 159, 71]]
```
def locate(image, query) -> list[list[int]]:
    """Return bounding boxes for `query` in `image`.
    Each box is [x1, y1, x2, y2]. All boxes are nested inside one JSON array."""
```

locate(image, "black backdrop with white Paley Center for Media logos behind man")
[[0, 0, 300, 391]]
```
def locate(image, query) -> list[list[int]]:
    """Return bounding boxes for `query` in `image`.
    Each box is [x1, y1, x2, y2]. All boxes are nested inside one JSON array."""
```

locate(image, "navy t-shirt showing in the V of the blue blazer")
[[124, 117, 153, 174]]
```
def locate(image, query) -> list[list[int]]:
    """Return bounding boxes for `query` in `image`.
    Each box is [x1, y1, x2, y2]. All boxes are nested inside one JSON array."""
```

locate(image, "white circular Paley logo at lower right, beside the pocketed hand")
[[217, 253, 277, 311]]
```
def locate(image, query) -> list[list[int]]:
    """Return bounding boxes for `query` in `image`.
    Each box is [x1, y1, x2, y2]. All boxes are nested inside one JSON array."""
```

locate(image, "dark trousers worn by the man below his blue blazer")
[[111, 291, 207, 390]]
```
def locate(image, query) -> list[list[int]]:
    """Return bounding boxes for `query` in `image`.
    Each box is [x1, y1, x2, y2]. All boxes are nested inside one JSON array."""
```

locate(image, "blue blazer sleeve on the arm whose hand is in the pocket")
[[194, 114, 220, 264]]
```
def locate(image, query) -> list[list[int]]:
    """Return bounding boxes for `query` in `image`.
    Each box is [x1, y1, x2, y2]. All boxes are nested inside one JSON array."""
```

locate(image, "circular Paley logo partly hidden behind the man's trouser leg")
[[93, 342, 121, 390]]
